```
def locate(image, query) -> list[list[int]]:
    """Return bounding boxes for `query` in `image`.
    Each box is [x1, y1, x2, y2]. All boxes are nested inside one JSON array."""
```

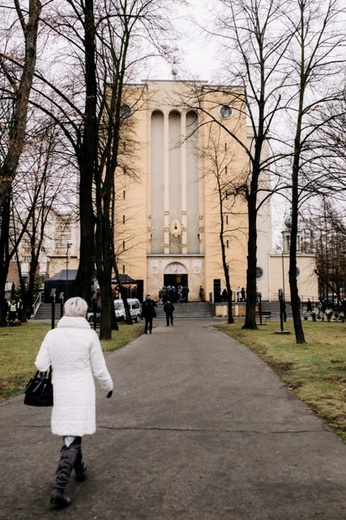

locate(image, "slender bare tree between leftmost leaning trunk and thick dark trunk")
[[10, 120, 73, 321]]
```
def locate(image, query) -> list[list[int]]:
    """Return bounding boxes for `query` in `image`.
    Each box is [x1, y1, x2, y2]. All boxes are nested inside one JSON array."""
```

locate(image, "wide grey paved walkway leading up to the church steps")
[[0, 319, 346, 520]]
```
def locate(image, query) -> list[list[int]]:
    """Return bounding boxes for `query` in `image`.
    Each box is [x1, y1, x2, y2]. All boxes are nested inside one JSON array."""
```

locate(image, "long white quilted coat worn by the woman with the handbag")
[[35, 316, 113, 437]]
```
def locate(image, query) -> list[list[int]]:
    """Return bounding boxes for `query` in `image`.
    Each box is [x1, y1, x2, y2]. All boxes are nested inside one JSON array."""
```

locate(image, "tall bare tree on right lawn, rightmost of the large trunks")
[[287, 0, 346, 343]]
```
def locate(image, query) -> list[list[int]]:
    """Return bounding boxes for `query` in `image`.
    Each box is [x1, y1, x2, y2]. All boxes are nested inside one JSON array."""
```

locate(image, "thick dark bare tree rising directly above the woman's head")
[[36, 0, 99, 301]]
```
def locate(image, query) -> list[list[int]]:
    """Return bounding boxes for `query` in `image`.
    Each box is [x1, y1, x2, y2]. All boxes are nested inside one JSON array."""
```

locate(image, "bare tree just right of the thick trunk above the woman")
[[90, 0, 180, 338]]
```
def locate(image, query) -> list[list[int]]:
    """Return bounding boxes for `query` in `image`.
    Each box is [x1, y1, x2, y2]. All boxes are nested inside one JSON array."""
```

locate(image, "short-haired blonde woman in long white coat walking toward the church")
[[35, 297, 113, 508]]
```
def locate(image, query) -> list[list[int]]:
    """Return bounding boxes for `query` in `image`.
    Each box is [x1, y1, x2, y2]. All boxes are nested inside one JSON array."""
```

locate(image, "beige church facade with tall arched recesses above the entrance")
[[115, 81, 271, 300]]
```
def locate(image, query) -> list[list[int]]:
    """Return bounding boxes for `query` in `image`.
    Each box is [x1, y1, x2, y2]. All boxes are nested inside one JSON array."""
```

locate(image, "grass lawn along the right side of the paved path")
[[217, 321, 346, 443]]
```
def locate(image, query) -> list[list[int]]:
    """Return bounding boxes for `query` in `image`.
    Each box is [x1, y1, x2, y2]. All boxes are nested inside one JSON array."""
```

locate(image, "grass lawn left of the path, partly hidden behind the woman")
[[0, 322, 143, 402]]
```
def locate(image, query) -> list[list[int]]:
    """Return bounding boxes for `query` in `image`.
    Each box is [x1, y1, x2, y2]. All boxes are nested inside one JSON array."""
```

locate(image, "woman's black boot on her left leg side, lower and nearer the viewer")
[[50, 437, 84, 508]]
